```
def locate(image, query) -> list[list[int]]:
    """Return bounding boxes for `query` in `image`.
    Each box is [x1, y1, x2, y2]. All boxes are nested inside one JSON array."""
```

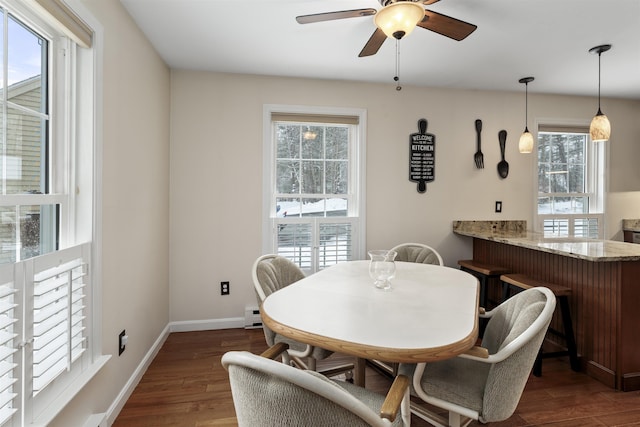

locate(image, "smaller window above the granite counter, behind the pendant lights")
[[537, 126, 605, 238]]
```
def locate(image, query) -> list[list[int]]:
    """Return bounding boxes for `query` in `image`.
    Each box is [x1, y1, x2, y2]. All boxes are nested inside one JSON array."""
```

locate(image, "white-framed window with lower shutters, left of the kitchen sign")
[[264, 106, 365, 273]]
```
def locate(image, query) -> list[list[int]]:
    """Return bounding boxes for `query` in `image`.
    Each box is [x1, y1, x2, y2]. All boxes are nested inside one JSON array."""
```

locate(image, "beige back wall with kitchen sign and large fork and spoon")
[[170, 70, 640, 321]]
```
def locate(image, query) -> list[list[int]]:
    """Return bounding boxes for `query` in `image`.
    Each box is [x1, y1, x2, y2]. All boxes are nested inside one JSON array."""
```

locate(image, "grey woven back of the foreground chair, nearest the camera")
[[222, 351, 401, 427]]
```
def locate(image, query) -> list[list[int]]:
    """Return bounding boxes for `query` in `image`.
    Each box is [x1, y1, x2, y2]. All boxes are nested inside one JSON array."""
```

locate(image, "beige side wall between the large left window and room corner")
[[51, 0, 170, 427]]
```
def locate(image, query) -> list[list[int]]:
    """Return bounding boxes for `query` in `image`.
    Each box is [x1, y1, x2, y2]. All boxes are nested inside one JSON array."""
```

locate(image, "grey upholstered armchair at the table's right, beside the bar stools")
[[399, 287, 556, 427]]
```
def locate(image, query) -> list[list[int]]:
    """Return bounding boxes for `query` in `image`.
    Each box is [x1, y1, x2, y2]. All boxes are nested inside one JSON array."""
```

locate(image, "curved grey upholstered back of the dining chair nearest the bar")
[[479, 287, 556, 423]]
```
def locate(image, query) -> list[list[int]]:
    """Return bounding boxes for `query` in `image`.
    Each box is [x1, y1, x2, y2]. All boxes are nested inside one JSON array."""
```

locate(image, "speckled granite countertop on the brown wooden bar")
[[453, 221, 640, 262]]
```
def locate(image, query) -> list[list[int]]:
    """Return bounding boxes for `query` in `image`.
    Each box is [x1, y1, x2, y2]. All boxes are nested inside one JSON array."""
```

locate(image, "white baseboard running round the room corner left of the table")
[[107, 317, 245, 425]]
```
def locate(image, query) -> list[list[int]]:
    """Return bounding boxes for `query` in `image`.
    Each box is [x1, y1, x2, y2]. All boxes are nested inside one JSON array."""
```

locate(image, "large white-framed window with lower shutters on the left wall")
[[0, 0, 107, 426]]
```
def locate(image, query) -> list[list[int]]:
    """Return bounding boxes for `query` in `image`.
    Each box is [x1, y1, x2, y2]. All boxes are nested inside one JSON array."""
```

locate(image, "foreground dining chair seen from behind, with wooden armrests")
[[222, 343, 411, 427]]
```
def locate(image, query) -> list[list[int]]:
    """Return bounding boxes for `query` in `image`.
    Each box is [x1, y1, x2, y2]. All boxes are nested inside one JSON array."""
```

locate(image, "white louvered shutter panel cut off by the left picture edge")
[[0, 265, 19, 425]]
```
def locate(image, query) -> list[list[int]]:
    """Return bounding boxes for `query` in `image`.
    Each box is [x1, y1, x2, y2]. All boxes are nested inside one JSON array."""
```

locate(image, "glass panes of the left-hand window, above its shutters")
[[0, 10, 54, 263]]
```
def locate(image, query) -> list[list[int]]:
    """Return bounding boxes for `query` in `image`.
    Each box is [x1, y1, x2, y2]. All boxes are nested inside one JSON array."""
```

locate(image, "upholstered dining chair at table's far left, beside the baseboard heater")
[[252, 254, 354, 380]]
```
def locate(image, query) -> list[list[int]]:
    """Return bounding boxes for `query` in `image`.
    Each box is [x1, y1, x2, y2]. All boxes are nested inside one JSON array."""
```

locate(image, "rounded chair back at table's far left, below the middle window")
[[252, 254, 305, 303]]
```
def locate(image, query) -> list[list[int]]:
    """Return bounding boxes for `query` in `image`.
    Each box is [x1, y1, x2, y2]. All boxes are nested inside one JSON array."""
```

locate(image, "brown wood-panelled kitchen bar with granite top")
[[453, 221, 640, 391]]
